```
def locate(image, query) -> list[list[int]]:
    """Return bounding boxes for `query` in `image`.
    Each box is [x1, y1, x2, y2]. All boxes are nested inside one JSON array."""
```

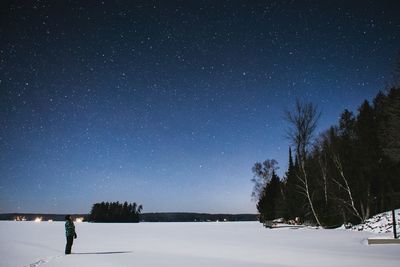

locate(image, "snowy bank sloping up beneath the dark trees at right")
[[351, 209, 400, 234]]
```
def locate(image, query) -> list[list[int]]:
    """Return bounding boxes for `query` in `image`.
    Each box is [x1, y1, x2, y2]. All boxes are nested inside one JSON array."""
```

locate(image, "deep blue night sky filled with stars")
[[0, 1, 400, 213]]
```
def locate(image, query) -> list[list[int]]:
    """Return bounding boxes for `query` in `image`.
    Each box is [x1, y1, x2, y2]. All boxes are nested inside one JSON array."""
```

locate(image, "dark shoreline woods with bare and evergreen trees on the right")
[[252, 86, 400, 227]]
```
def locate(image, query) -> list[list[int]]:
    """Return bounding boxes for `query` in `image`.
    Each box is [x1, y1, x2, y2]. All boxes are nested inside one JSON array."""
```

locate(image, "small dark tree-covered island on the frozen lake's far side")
[[89, 201, 143, 223]]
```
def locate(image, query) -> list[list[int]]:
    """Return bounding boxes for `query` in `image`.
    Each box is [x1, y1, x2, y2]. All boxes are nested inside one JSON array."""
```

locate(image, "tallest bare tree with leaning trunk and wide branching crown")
[[285, 100, 321, 225]]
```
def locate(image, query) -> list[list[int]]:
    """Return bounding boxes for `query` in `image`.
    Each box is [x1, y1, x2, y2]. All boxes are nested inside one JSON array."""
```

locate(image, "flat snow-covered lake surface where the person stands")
[[0, 221, 400, 267]]
